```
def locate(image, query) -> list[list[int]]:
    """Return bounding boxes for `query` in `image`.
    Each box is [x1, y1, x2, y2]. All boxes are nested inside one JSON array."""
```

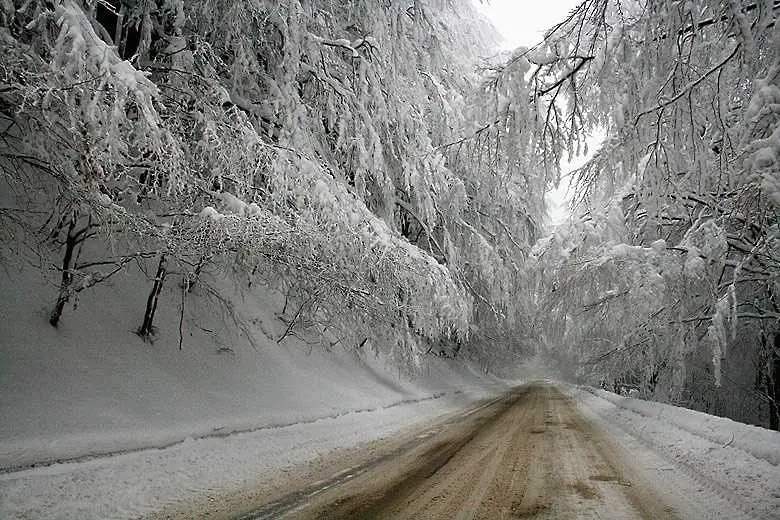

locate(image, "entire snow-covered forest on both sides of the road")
[[0, 0, 780, 430]]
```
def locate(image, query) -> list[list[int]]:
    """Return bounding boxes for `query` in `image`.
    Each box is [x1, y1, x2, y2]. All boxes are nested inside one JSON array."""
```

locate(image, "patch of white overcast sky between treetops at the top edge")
[[474, 0, 582, 49]]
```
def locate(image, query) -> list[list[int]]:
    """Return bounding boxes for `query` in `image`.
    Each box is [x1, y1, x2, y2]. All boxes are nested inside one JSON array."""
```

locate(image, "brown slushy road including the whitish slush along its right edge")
[[150, 382, 780, 520]]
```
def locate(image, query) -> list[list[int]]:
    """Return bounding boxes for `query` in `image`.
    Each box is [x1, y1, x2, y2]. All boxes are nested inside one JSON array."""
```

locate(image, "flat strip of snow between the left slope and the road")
[[0, 394, 496, 520]]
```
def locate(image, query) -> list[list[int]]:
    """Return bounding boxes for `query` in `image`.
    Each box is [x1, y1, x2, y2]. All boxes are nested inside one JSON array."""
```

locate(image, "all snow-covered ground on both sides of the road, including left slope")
[[0, 262, 780, 520]]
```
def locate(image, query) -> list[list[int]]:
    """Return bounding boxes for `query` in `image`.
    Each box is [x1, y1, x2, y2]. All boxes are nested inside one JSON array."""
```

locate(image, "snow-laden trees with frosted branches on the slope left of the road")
[[0, 0, 543, 366]]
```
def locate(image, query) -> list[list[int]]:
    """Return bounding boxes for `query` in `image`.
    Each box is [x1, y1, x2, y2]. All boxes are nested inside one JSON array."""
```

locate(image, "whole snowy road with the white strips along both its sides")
[[0, 382, 780, 520]]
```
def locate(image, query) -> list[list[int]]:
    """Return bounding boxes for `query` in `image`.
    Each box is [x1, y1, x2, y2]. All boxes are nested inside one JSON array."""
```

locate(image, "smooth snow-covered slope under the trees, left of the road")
[[0, 256, 512, 471]]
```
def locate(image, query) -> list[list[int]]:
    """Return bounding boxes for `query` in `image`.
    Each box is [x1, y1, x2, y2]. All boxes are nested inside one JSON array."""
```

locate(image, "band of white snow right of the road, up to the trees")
[[569, 387, 780, 518]]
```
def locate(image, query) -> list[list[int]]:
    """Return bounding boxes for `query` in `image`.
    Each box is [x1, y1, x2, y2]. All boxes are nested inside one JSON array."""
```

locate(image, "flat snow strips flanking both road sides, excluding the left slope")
[[0, 382, 780, 519]]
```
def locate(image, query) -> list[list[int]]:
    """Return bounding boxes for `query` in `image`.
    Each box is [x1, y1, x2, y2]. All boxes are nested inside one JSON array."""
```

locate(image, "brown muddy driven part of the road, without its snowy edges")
[[242, 383, 676, 520]]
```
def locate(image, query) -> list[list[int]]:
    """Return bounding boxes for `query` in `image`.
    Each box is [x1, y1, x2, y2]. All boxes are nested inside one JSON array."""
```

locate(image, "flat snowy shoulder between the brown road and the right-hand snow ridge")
[[563, 386, 780, 520]]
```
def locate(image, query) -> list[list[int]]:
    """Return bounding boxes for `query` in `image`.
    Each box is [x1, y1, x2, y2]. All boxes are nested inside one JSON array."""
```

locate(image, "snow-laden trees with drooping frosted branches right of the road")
[[512, 0, 780, 428]]
